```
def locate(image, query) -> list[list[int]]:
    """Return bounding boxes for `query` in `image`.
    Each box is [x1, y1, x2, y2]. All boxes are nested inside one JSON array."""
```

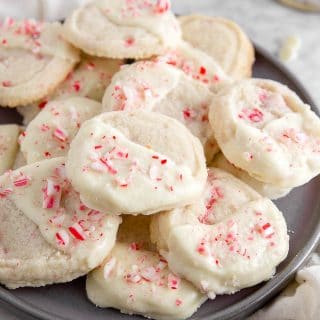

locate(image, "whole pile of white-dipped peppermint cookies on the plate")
[[0, 0, 320, 319]]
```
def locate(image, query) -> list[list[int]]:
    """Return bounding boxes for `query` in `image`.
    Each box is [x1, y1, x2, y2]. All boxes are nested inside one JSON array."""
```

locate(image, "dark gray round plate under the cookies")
[[0, 48, 320, 320]]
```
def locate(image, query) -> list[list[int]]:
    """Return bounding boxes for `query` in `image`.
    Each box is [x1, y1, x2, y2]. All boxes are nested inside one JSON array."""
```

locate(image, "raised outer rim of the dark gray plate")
[[0, 43, 320, 320]]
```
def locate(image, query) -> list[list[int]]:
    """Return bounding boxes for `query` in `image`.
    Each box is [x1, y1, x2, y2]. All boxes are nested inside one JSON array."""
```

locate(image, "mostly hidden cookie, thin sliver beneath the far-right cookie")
[[210, 152, 291, 200]]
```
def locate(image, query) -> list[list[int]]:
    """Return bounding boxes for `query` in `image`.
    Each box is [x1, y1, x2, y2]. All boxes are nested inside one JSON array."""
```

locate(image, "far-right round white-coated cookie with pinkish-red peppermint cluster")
[[209, 79, 320, 189]]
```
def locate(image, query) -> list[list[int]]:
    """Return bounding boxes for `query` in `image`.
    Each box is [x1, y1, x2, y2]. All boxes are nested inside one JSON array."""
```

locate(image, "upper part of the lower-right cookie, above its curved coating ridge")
[[150, 168, 261, 252]]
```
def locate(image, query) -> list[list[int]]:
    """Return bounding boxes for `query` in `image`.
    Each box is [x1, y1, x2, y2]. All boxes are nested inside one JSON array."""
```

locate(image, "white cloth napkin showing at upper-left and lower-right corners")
[[0, 0, 320, 320]]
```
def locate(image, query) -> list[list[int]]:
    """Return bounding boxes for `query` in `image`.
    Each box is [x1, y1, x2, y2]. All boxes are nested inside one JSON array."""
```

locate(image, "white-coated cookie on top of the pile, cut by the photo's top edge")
[[64, 0, 181, 59]]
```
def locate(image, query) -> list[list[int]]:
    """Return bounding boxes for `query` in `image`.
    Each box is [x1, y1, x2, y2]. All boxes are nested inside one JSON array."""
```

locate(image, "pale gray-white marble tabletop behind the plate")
[[0, 0, 320, 320]]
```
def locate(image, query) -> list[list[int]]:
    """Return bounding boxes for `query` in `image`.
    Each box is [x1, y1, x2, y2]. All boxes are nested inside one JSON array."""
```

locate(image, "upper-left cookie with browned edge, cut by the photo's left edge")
[[0, 19, 79, 107]]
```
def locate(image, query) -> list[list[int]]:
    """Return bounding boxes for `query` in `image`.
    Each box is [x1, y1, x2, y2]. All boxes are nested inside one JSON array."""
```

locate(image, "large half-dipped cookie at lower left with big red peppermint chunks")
[[0, 158, 121, 288]]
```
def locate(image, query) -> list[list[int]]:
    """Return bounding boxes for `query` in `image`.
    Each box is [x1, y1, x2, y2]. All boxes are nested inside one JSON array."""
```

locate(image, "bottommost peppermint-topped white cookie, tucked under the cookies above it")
[[86, 215, 206, 320]]
